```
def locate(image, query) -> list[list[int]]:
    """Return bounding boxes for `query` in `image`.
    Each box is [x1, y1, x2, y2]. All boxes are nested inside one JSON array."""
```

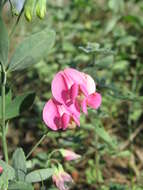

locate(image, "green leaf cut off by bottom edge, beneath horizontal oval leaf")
[[8, 181, 34, 190]]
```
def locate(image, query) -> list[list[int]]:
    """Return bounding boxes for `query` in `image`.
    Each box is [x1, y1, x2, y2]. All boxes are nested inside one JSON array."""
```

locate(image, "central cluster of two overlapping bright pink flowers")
[[43, 68, 101, 131]]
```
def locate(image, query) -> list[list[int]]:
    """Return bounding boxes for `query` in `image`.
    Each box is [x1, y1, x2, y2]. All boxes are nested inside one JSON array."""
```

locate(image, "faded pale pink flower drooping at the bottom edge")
[[52, 164, 73, 190]]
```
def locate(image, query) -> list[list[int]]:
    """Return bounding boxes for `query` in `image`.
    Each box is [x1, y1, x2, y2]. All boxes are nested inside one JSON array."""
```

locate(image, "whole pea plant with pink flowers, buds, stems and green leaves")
[[0, 0, 101, 190]]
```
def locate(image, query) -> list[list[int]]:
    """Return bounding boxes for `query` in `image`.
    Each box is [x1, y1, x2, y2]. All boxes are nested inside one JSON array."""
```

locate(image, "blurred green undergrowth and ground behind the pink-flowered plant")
[[2, 0, 143, 190]]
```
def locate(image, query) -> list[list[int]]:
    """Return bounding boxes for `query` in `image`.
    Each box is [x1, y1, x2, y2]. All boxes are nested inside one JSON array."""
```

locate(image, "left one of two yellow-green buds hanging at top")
[[24, 0, 36, 22]]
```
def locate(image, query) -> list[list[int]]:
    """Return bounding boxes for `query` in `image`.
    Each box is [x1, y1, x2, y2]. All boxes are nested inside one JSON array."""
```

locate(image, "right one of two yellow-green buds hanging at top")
[[36, 0, 46, 19]]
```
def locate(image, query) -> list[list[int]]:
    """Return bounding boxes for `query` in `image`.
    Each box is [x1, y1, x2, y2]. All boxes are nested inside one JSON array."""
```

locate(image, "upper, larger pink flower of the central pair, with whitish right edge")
[[52, 68, 101, 113]]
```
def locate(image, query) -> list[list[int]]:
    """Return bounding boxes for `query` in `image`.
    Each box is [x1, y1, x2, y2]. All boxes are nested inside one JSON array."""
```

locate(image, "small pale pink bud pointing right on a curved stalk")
[[60, 149, 81, 161]]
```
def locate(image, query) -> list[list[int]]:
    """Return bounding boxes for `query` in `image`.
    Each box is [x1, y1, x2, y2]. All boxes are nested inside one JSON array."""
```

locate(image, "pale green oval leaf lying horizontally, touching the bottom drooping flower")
[[25, 168, 54, 183]]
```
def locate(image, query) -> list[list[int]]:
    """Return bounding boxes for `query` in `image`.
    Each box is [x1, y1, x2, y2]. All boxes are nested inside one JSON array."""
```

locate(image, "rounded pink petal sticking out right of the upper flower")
[[87, 92, 102, 109]]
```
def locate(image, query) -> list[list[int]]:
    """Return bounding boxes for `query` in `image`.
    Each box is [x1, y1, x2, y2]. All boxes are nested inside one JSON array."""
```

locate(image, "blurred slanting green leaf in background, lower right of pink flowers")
[[94, 125, 117, 149]]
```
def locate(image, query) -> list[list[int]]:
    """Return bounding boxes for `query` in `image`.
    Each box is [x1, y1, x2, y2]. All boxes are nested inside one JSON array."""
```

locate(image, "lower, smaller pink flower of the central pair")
[[43, 99, 80, 131]]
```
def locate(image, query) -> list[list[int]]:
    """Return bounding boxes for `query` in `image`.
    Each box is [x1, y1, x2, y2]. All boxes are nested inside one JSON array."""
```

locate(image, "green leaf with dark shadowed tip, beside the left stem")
[[0, 92, 35, 119]]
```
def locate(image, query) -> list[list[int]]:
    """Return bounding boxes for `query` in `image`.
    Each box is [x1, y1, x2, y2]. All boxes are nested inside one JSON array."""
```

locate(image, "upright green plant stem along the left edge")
[[1, 64, 8, 163]]
